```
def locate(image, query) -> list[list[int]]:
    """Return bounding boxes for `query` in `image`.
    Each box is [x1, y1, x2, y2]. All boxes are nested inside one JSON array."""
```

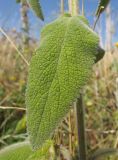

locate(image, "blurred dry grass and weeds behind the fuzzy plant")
[[0, 2, 118, 160]]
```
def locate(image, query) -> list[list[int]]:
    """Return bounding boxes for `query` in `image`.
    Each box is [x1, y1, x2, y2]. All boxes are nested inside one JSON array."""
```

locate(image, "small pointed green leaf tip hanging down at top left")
[[28, 0, 44, 20]]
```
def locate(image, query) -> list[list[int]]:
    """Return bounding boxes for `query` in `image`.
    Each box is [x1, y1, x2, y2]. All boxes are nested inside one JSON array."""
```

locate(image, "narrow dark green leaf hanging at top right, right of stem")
[[96, 0, 110, 16]]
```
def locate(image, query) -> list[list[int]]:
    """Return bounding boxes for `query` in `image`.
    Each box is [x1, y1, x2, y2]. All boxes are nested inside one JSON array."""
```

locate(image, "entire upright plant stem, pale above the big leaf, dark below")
[[68, 0, 87, 160]]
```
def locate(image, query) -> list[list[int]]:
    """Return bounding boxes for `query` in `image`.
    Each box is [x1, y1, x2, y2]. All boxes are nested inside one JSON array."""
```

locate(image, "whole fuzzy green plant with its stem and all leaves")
[[0, 0, 118, 160]]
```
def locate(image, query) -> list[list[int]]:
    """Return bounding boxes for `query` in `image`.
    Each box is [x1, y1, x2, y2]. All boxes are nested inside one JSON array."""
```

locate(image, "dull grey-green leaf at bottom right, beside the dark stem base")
[[89, 148, 118, 160]]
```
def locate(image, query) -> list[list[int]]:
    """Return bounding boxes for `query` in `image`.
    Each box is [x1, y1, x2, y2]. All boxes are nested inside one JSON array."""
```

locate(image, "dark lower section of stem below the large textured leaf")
[[75, 94, 87, 160]]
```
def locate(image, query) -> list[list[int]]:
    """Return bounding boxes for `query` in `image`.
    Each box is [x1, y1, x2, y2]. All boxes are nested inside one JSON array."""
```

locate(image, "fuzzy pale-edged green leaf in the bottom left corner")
[[0, 142, 33, 160]]
